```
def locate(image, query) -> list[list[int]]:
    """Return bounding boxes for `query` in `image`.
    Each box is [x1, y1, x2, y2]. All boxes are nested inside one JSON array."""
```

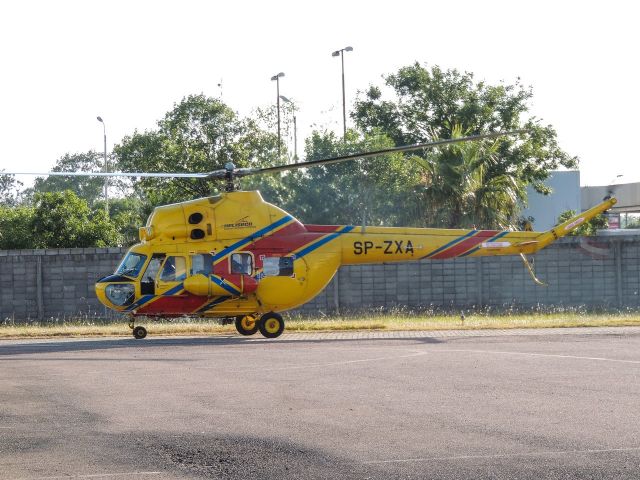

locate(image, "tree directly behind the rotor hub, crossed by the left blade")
[[114, 95, 277, 205]]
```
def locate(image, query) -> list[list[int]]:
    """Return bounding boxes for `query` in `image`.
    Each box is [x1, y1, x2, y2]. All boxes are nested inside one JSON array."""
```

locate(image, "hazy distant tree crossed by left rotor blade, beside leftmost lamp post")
[[33, 151, 105, 205]]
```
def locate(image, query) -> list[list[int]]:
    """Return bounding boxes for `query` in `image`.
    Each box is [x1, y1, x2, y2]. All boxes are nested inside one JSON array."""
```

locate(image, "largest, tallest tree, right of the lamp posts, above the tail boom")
[[351, 63, 577, 226]]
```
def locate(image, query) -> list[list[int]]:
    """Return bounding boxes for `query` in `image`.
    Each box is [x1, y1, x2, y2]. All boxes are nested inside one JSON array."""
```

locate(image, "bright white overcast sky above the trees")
[[0, 0, 640, 185]]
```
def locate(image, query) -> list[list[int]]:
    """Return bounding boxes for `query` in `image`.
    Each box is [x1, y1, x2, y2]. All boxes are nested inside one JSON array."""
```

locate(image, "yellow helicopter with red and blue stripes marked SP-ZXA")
[[5, 131, 616, 339]]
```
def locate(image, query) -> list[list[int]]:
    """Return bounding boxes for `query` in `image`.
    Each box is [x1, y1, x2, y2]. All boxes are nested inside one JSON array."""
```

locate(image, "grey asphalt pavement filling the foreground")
[[0, 327, 640, 480]]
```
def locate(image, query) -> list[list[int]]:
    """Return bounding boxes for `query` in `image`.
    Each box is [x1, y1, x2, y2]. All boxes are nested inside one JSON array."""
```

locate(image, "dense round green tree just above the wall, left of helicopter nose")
[[30, 190, 121, 248]]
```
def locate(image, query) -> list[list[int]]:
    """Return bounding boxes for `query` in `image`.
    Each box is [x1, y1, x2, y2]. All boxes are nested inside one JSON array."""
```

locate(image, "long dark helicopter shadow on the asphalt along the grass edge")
[[0, 336, 445, 362]]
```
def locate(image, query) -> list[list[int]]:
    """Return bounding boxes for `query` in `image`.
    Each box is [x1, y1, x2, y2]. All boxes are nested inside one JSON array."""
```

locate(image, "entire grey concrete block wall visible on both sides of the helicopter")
[[0, 236, 640, 322]]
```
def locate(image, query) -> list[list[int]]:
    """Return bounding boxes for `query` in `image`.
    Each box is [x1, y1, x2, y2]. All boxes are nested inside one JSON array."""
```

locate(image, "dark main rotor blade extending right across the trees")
[[235, 130, 525, 177]]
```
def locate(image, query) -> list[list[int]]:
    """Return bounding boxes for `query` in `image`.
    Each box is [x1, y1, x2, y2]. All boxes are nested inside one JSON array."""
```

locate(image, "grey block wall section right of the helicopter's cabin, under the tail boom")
[[298, 236, 640, 314]]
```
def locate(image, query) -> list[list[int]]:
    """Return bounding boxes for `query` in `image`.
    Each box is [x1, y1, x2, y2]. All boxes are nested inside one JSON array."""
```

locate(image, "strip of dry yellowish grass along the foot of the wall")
[[0, 311, 640, 338]]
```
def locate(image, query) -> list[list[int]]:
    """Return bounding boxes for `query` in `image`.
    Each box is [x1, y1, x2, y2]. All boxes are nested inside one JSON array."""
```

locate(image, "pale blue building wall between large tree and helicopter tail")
[[522, 170, 584, 231]]
